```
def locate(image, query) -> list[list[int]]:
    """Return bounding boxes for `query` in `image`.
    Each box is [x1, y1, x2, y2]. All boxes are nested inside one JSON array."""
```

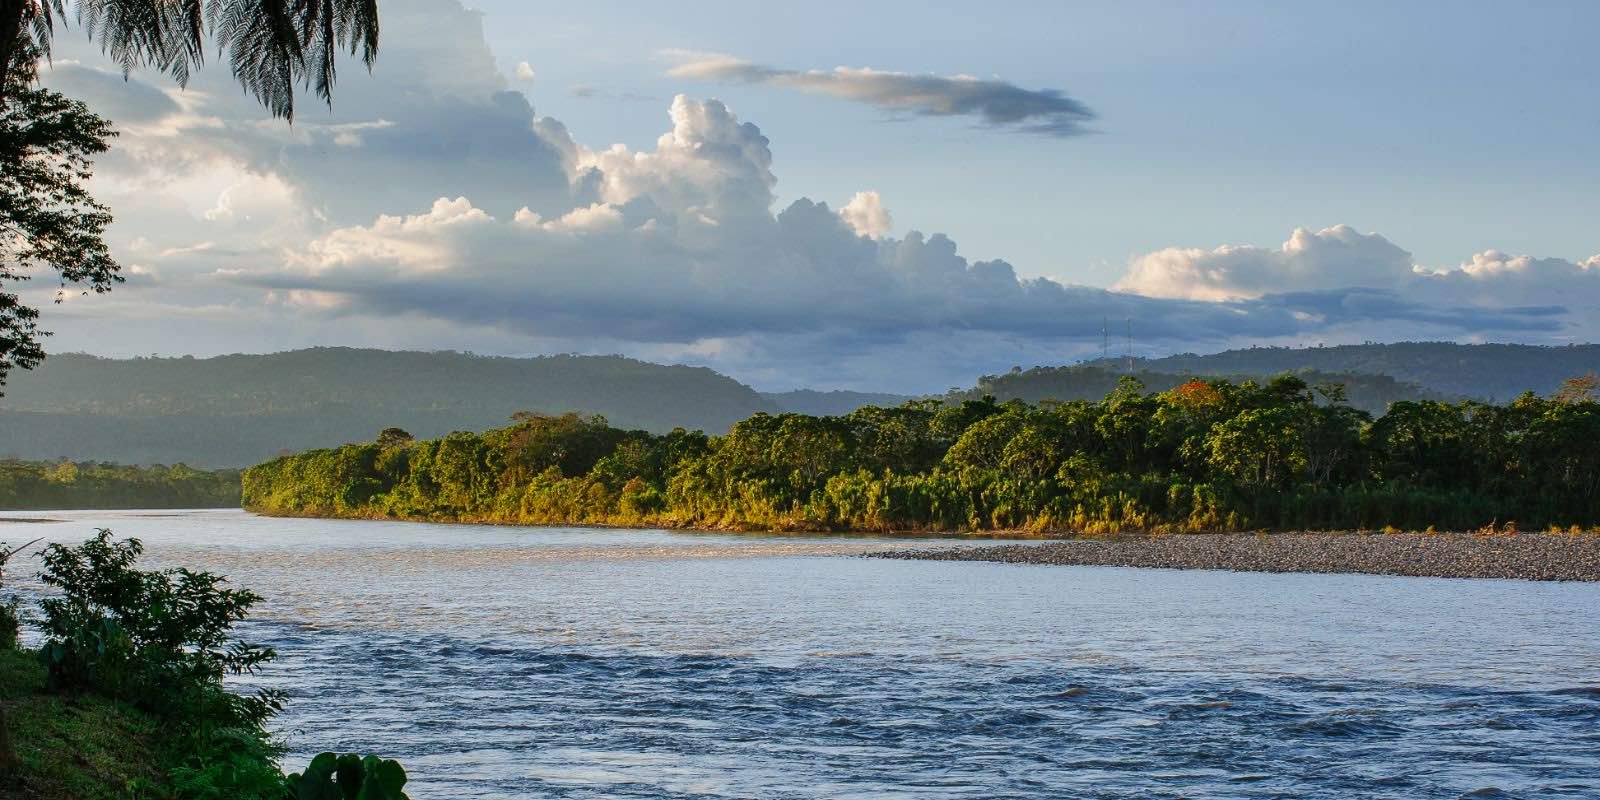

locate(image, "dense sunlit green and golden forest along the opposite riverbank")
[[242, 374, 1600, 536]]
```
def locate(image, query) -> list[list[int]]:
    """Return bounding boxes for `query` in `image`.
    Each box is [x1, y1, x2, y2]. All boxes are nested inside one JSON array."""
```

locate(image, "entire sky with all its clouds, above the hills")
[[21, 0, 1600, 392]]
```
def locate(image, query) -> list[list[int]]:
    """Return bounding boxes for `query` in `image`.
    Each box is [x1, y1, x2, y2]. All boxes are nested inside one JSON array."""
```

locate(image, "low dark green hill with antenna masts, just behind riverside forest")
[[946, 362, 1448, 416]]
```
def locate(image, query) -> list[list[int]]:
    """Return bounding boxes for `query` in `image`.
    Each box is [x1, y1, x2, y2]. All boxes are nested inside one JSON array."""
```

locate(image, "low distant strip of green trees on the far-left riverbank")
[[0, 459, 240, 510]]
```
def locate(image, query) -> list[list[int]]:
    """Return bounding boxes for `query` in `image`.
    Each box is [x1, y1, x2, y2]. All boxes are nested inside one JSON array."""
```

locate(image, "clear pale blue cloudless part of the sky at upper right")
[[472, 0, 1600, 283]]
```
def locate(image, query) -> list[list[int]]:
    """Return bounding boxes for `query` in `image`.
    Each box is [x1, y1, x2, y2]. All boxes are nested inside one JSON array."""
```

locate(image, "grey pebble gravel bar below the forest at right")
[[867, 533, 1600, 581]]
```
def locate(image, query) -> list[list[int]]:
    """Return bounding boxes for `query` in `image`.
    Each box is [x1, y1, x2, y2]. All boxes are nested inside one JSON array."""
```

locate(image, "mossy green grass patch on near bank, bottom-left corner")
[[0, 650, 168, 800]]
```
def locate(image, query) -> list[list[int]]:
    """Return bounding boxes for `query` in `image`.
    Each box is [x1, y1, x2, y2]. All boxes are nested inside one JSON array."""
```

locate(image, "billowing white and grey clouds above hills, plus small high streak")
[[25, 0, 1600, 390]]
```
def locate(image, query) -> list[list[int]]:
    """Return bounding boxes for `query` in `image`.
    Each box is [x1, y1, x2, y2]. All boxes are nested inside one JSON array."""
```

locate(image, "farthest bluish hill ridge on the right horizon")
[[1138, 342, 1600, 402]]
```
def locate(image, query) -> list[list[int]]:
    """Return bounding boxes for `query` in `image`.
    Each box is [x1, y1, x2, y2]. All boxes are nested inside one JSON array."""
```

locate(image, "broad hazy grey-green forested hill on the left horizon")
[[0, 347, 776, 467]]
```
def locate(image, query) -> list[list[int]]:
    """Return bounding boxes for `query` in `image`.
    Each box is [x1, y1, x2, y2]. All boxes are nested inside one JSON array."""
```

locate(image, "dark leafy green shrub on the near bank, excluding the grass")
[[10, 530, 419, 800]]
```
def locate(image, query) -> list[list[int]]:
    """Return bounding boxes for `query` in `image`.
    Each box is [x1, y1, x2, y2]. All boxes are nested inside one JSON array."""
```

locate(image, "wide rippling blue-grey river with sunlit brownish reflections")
[[0, 512, 1600, 800]]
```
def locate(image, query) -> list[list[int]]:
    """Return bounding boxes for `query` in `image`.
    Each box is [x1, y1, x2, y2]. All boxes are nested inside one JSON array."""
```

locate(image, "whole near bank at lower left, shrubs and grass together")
[[0, 530, 406, 800]]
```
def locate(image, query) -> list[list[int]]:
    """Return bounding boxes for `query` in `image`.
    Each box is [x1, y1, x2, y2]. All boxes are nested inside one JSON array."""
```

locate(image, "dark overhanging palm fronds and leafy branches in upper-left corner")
[[0, 0, 378, 393]]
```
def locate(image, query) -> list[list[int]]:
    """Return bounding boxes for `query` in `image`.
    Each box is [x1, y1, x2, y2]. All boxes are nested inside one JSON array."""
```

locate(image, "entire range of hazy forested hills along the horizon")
[[0, 342, 1600, 467]]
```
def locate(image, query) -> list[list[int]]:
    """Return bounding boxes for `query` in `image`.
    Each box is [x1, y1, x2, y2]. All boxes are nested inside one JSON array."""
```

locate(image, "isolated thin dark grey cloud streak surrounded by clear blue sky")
[[669, 54, 1094, 136]]
